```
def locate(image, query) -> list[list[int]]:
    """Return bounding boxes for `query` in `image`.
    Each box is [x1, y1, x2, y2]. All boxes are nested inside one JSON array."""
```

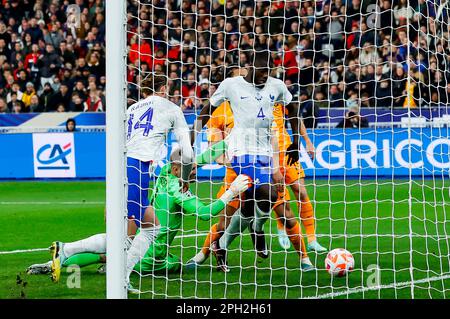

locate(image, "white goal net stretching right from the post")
[[116, 0, 450, 298]]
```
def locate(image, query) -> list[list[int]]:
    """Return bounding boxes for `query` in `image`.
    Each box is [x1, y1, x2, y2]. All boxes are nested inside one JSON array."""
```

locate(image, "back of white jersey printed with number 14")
[[127, 95, 188, 162]]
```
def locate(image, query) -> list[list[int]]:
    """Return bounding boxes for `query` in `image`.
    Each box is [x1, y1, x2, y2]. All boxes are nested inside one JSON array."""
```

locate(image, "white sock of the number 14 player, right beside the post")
[[127, 225, 161, 281]]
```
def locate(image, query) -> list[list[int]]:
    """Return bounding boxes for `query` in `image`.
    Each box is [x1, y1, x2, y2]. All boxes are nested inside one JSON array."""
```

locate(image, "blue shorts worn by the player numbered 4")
[[231, 155, 272, 188]]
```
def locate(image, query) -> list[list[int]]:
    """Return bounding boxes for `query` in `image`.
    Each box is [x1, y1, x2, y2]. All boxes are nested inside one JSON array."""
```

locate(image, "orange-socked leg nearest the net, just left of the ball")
[[274, 202, 314, 271]]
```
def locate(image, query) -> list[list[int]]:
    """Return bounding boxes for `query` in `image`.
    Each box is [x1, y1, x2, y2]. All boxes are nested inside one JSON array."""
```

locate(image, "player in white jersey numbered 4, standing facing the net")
[[195, 51, 299, 271]]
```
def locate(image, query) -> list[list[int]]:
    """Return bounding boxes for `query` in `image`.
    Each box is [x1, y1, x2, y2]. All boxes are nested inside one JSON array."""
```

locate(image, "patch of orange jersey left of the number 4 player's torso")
[[206, 101, 234, 142]]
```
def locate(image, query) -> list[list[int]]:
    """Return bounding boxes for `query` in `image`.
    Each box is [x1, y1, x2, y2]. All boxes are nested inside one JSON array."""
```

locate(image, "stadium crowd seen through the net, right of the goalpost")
[[128, 0, 450, 114]]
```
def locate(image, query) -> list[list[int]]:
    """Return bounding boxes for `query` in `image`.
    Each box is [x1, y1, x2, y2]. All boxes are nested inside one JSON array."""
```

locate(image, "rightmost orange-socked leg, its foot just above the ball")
[[290, 178, 327, 252]]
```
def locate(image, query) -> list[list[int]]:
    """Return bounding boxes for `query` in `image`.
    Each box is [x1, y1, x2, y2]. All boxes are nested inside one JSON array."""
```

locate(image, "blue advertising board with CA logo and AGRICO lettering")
[[0, 126, 450, 179]]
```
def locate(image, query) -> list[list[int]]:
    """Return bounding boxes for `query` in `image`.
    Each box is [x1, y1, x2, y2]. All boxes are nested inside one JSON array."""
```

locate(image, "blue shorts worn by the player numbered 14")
[[127, 157, 154, 227]]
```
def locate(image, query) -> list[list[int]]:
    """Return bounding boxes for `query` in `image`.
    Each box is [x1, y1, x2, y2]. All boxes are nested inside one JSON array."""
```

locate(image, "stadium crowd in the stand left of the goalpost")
[[0, 0, 106, 113]]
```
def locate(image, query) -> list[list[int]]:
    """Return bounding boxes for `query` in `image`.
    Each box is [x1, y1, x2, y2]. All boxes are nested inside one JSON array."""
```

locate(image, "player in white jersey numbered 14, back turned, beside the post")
[[52, 74, 194, 291]]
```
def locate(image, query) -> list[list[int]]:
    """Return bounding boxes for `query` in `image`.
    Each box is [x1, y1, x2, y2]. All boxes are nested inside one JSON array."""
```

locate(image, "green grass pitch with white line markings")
[[0, 178, 450, 298]]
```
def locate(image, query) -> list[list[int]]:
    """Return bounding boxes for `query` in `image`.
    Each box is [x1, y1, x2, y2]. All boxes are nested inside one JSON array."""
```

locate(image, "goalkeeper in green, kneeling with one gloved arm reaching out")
[[27, 146, 250, 281]]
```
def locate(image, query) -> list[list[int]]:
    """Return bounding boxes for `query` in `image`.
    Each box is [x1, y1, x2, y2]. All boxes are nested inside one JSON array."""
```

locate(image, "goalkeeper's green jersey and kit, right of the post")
[[134, 164, 225, 272]]
